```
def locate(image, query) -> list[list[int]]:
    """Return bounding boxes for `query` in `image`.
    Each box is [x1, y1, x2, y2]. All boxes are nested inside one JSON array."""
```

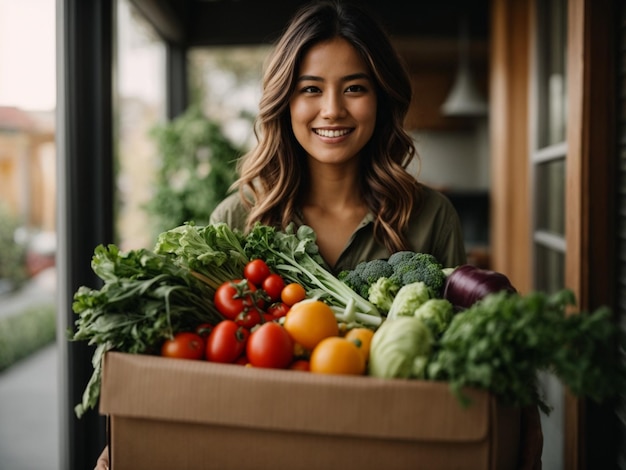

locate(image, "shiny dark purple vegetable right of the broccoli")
[[443, 264, 517, 309]]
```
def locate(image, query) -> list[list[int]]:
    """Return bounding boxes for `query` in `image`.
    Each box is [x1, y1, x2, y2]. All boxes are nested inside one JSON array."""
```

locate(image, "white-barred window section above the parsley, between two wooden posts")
[[530, 0, 567, 292]]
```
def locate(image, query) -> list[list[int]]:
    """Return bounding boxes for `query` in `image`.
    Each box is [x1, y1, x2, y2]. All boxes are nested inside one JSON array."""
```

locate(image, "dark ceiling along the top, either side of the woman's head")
[[131, 0, 490, 47]]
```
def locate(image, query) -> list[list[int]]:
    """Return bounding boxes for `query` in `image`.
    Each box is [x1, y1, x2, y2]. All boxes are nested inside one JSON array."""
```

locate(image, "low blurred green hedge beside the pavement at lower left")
[[0, 304, 56, 372]]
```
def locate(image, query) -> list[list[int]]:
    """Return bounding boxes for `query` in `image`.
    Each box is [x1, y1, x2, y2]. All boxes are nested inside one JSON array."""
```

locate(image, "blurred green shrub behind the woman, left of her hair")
[[146, 106, 243, 239]]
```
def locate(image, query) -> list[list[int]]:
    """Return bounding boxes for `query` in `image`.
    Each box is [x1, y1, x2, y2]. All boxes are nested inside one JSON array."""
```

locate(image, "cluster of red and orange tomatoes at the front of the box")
[[161, 259, 373, 375]]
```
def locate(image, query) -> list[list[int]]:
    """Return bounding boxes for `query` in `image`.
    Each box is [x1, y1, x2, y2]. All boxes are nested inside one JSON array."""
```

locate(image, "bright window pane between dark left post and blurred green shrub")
[[114, 0, 166, 249]]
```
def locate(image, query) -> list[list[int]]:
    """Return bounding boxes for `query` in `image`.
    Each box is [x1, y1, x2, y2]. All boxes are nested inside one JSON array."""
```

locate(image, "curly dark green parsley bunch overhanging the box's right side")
[[428, 289, 626, 414]]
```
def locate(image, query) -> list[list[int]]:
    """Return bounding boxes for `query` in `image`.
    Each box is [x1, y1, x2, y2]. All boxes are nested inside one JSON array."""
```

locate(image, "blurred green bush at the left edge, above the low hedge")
[[0, 203, 28, 288]]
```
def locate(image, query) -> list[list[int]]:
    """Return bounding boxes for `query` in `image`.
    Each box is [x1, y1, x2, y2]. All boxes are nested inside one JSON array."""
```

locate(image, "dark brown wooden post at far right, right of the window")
[[564, 0, 617, 469]]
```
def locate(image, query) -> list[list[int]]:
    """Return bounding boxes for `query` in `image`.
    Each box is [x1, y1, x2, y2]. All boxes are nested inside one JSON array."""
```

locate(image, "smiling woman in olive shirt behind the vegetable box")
[[211, 3, 466, 272]]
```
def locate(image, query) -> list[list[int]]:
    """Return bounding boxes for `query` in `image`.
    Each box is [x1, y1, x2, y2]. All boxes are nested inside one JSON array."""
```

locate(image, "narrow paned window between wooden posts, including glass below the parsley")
[[530, 0, 567, 469]]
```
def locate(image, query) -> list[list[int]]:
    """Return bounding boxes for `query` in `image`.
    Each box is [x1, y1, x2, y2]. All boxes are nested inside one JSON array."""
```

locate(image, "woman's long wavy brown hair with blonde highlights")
[[235, 1, 421, 252]]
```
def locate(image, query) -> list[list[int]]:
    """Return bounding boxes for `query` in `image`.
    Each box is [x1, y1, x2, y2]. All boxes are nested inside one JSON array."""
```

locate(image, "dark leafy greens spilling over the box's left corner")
[[68, 245, 221, 417]]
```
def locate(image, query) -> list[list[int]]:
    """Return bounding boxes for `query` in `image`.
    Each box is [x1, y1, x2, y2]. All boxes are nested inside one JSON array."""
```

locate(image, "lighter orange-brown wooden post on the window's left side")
[[489, 0, 532, 292]]
